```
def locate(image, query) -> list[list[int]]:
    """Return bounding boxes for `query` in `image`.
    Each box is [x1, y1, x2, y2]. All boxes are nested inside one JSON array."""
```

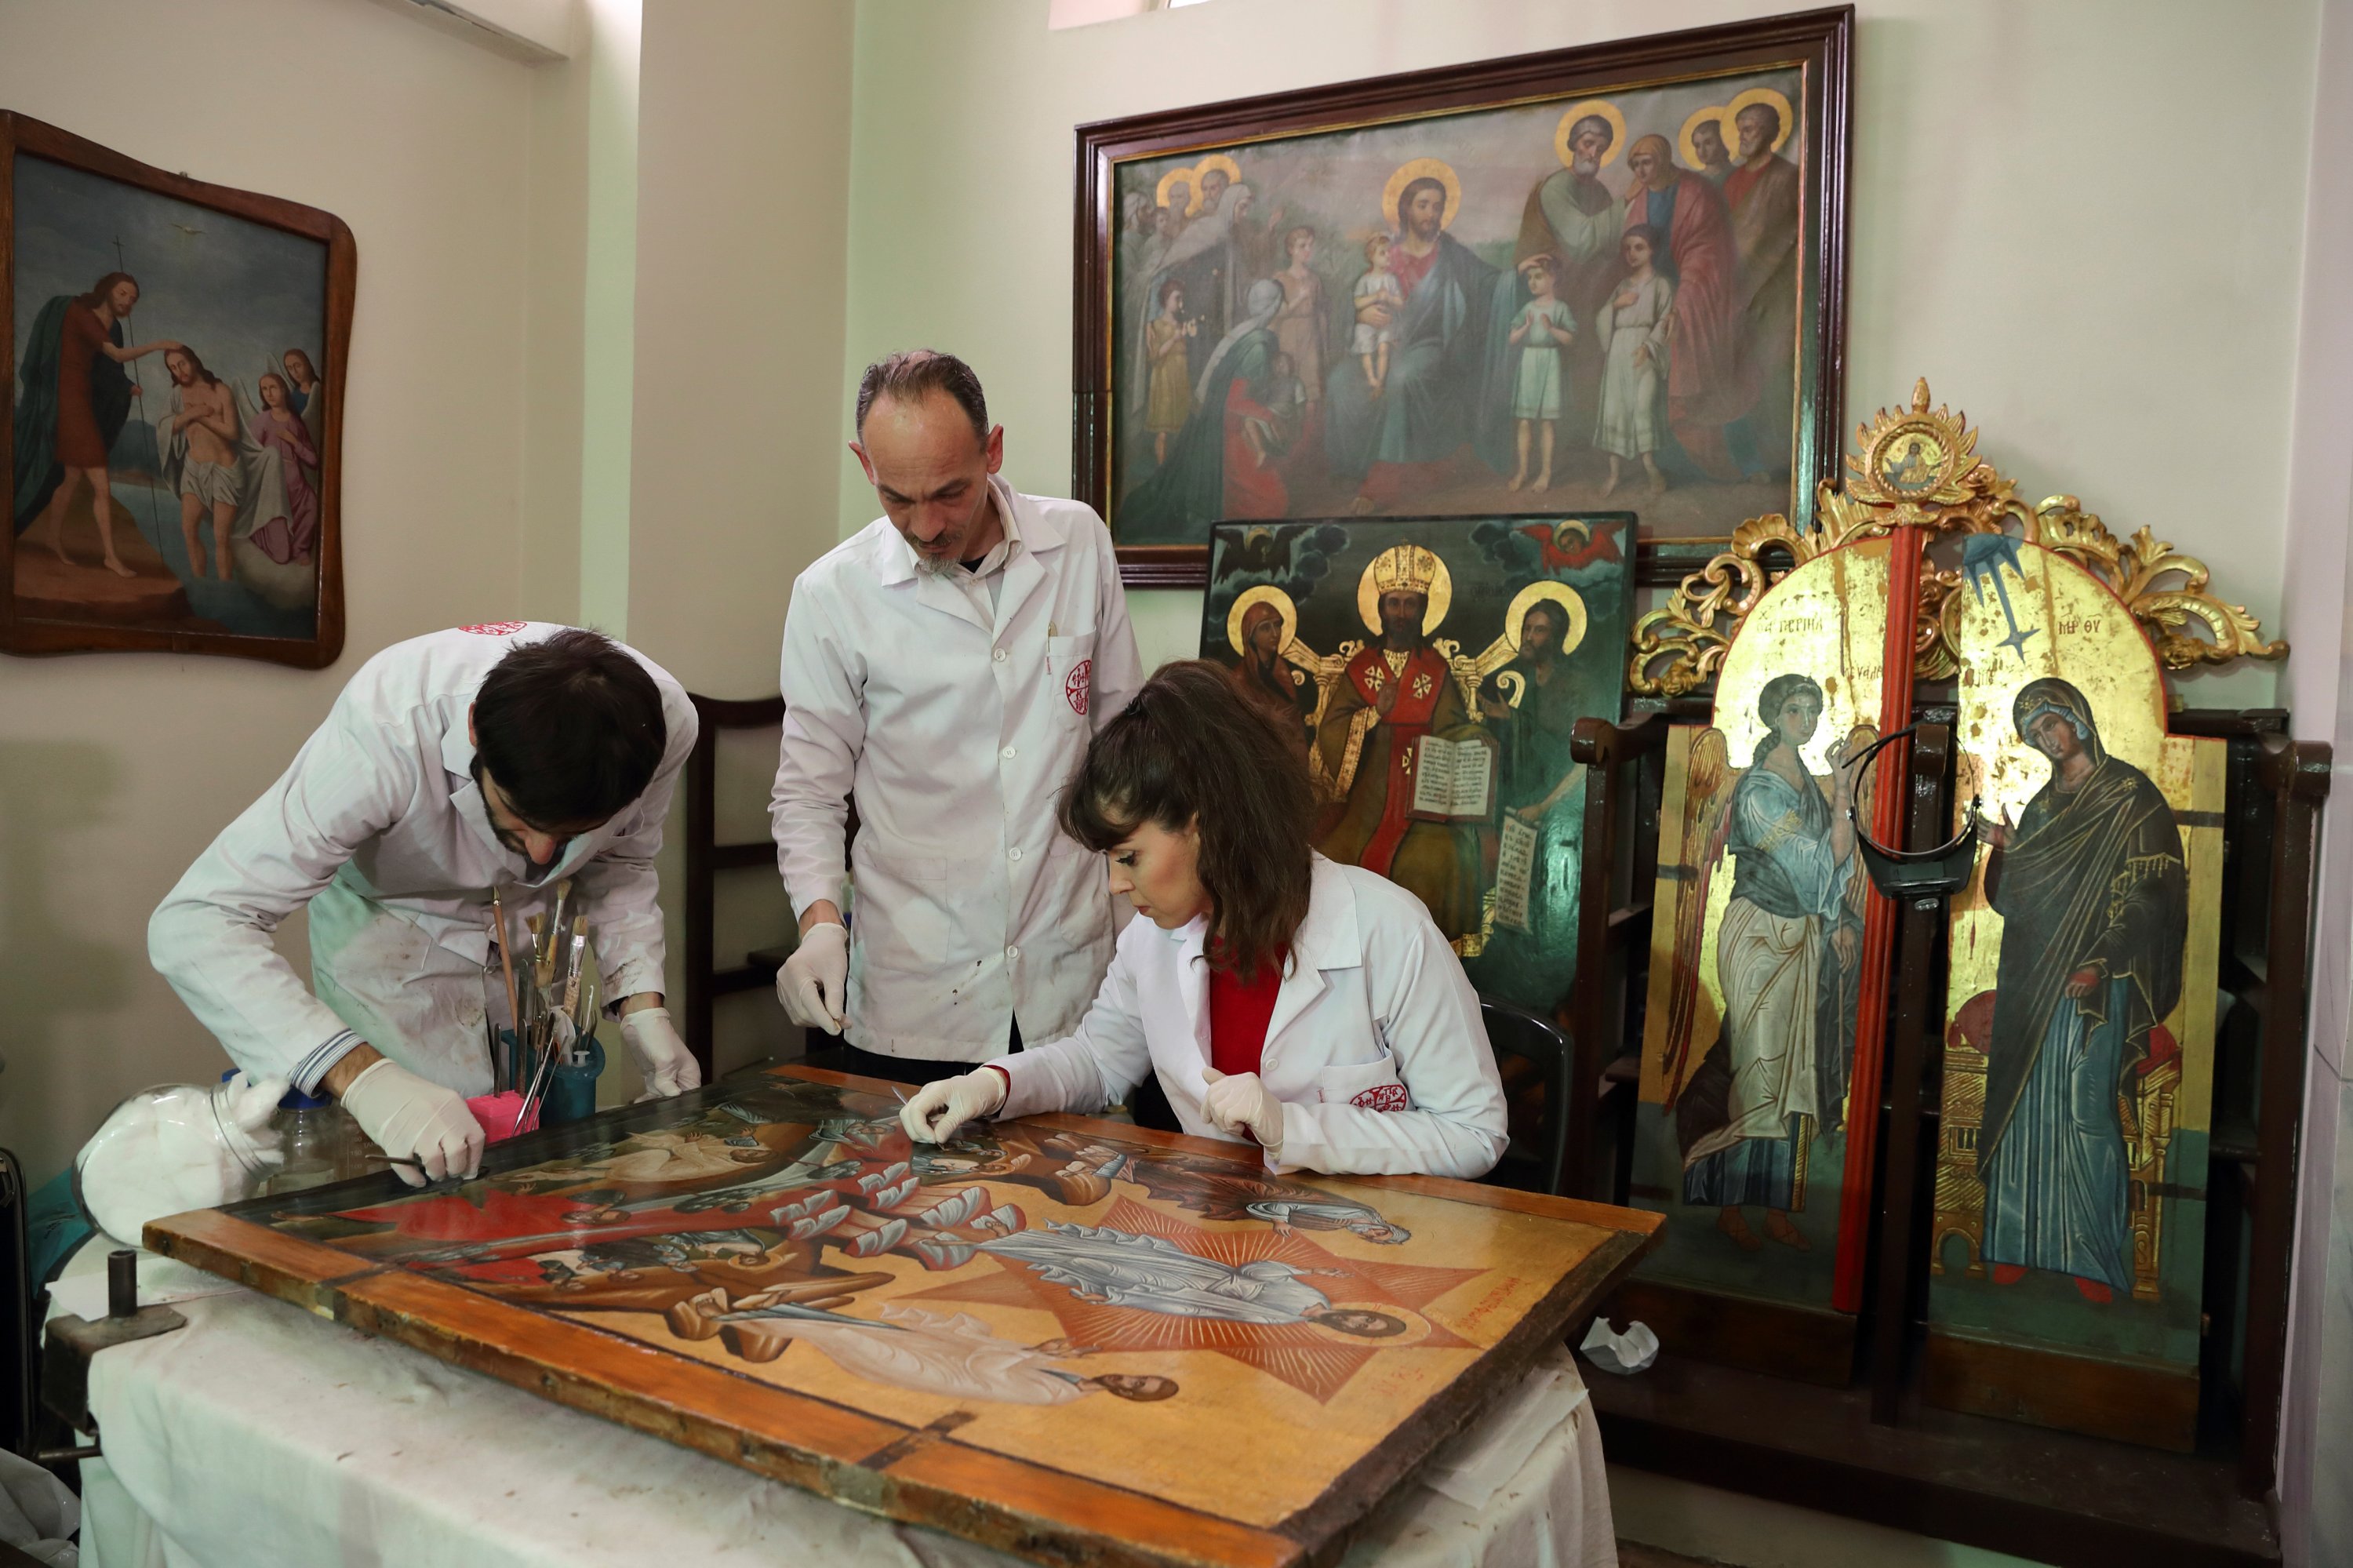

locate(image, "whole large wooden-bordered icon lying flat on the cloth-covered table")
[[146, 1069, 1657, 1568]]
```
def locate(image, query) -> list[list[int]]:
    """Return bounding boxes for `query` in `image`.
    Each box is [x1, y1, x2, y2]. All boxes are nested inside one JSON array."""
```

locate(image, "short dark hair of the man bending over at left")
[[473, 628, 671, 831]]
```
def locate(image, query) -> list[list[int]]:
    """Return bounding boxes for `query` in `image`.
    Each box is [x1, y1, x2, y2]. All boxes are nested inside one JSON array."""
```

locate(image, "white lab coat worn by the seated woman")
[[998, 855, 1508, 1180]]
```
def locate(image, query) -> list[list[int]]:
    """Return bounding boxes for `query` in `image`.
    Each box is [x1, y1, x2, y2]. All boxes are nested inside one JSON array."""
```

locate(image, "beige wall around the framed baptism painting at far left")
[[0, 0, 546, 1177]]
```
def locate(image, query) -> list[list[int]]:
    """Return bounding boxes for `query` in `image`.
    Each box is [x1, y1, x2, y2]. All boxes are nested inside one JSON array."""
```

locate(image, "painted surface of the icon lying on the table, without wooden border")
[[238, 1079, 1605, 1526]]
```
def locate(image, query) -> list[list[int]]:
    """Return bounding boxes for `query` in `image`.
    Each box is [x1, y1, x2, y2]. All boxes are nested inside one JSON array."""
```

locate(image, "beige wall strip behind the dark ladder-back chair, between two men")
[[609, 0, 852, 1068]]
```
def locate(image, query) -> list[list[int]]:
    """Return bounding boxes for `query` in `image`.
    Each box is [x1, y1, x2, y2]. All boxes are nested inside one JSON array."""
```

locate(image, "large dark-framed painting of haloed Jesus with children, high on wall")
[[1073, 7, 1854, 586]]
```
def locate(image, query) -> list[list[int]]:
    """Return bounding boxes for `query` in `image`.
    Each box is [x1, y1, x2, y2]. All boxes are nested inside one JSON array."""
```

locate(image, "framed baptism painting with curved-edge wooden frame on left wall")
[[0, 111, 358, 668]]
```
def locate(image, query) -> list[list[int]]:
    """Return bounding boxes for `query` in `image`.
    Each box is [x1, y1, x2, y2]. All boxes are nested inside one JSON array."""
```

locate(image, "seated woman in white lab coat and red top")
[[901, 661, 1506, 1177]]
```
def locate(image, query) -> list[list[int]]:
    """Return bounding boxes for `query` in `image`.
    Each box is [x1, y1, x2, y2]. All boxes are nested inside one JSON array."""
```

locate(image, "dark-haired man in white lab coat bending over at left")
[[148, 621, 701, 1184]]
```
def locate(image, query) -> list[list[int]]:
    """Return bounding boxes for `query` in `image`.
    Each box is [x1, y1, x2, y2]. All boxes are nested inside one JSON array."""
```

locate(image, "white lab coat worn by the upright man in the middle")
[[769, 478, 1144, 1062]]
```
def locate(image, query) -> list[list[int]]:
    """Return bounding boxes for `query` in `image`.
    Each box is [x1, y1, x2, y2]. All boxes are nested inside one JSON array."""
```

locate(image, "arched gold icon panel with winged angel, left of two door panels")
[[1633, 541, 1887, 1307]]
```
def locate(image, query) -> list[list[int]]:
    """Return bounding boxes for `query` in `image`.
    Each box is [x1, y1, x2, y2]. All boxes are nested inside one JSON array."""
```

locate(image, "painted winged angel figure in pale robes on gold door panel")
[[1666, 673, 1873, 1253]]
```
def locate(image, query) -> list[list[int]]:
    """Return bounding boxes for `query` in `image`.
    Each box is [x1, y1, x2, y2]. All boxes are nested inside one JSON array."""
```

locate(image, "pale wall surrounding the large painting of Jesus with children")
[[842, 0, 2315, 704]]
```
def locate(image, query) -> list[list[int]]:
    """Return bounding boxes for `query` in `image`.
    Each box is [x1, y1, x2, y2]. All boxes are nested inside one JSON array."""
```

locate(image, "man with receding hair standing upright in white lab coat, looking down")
[[769, 351, 1144, 1083]]
